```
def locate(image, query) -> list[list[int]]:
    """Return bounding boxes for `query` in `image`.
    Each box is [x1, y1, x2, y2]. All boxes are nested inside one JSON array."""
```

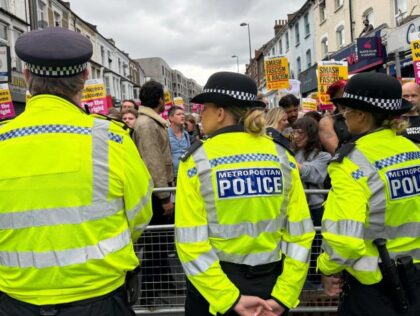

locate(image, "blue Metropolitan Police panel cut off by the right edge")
[[386, 167, 420, 200]]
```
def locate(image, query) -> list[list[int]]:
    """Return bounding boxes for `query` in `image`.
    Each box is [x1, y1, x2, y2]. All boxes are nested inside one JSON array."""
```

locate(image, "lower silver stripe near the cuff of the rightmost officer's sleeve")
[[322, 239, 379, 272]]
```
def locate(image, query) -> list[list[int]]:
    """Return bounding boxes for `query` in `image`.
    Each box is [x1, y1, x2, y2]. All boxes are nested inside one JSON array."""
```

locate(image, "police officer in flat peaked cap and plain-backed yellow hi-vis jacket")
[[0, 28, 153, 316]]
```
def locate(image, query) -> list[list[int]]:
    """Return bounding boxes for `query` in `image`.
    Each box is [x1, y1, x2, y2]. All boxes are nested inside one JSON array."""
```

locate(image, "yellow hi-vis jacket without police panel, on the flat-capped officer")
[[0, 95, 153, 305]]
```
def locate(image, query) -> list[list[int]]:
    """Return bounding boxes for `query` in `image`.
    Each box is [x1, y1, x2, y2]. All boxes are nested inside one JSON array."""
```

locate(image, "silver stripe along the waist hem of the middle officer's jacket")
[[215, 243, 281, 266]]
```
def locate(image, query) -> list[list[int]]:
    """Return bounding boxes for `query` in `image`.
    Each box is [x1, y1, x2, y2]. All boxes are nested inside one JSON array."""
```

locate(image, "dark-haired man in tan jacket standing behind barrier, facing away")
[[133, 81, 174, 306]]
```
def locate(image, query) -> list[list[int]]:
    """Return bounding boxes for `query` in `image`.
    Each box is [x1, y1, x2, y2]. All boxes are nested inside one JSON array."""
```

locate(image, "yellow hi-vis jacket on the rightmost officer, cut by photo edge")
[[318, 129, 420, 284]]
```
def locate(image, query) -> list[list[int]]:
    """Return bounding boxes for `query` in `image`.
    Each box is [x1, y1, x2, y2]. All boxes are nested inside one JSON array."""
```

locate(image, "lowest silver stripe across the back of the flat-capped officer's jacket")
[[0, 229, 131, 269]]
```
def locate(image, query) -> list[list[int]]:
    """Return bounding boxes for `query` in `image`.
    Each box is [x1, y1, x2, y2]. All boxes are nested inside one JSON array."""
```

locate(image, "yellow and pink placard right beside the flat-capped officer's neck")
[[81, 79, 109, 115]]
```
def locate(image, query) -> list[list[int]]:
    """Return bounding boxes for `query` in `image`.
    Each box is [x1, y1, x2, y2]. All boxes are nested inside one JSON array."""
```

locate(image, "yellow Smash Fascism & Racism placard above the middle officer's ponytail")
[[264, 57, 289, 90]]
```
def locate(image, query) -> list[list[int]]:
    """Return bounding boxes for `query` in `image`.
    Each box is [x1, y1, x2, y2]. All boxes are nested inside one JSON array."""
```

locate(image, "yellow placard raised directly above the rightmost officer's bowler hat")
[[317, 60, 349, 108]]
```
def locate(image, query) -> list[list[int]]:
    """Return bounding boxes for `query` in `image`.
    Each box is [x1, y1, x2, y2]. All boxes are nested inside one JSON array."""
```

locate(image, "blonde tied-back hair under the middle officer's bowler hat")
[[225, 106, 265, 136]]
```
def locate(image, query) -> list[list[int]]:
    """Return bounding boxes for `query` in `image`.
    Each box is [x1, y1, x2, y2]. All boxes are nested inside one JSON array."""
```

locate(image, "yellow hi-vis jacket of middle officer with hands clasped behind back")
[[175, 128, 314, 315]]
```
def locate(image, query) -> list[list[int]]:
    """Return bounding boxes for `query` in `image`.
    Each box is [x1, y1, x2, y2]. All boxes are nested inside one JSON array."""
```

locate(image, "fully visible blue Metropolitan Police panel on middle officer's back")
[[216, 168, 283, 199]]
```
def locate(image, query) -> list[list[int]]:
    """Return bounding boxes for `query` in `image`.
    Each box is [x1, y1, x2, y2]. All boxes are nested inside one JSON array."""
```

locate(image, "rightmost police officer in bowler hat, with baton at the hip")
[[318, 73, 420, 316]]
